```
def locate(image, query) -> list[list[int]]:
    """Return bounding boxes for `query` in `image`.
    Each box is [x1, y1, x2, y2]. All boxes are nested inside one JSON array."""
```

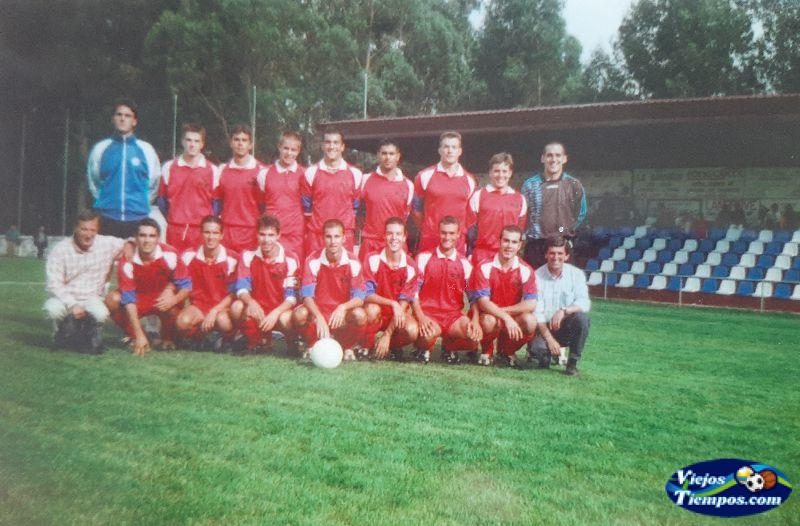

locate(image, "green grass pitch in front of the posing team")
[[0, 258, 800, 525]]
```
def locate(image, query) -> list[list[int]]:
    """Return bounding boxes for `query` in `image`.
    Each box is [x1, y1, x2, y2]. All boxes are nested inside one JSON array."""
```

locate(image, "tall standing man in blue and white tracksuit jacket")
[[86, 101, 161, 237]]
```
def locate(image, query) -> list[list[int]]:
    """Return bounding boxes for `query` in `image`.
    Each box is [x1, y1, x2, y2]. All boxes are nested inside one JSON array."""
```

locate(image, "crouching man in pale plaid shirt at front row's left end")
[[44, 210, 125, 354]]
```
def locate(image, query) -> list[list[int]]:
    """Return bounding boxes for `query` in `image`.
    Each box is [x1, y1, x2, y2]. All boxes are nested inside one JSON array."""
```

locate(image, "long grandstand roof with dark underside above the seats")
[[328, 94, 800, 170]]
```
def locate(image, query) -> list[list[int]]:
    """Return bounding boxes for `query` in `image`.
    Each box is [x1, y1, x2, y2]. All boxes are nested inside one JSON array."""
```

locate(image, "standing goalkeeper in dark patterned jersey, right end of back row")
[[521, 142, 586, 268]]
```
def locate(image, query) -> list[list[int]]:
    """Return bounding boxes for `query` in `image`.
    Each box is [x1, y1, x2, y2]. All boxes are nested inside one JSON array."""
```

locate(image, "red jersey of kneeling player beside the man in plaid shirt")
[[117, 245, 192, 310]]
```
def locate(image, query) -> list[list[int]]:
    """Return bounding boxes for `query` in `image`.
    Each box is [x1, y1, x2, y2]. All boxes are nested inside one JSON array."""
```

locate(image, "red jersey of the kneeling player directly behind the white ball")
[[300, 249, 367, 318]]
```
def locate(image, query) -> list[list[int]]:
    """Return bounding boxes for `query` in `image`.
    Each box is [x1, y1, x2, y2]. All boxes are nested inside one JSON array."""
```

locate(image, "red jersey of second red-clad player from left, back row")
[[217, 155, 266, 230]]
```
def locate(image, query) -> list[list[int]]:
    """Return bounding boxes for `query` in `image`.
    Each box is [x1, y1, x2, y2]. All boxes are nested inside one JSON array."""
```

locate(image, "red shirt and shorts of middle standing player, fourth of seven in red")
[[300, 159, 362, 254]]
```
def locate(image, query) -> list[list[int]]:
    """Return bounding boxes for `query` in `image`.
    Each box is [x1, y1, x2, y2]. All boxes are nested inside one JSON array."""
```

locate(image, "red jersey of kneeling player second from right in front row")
[[417, 247, 472, 317]]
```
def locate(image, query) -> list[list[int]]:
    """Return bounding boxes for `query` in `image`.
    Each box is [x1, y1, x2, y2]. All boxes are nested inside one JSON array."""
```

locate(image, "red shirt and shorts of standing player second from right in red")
[[414, 163, 475, 253]]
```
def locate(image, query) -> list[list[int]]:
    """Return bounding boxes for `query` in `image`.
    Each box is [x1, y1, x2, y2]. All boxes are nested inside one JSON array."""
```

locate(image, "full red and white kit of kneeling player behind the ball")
[[300, 249, 367, 349]]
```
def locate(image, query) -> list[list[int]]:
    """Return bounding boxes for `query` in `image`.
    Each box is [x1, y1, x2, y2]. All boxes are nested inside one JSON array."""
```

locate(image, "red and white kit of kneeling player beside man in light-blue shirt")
[[470, 255, 537, 356]]
